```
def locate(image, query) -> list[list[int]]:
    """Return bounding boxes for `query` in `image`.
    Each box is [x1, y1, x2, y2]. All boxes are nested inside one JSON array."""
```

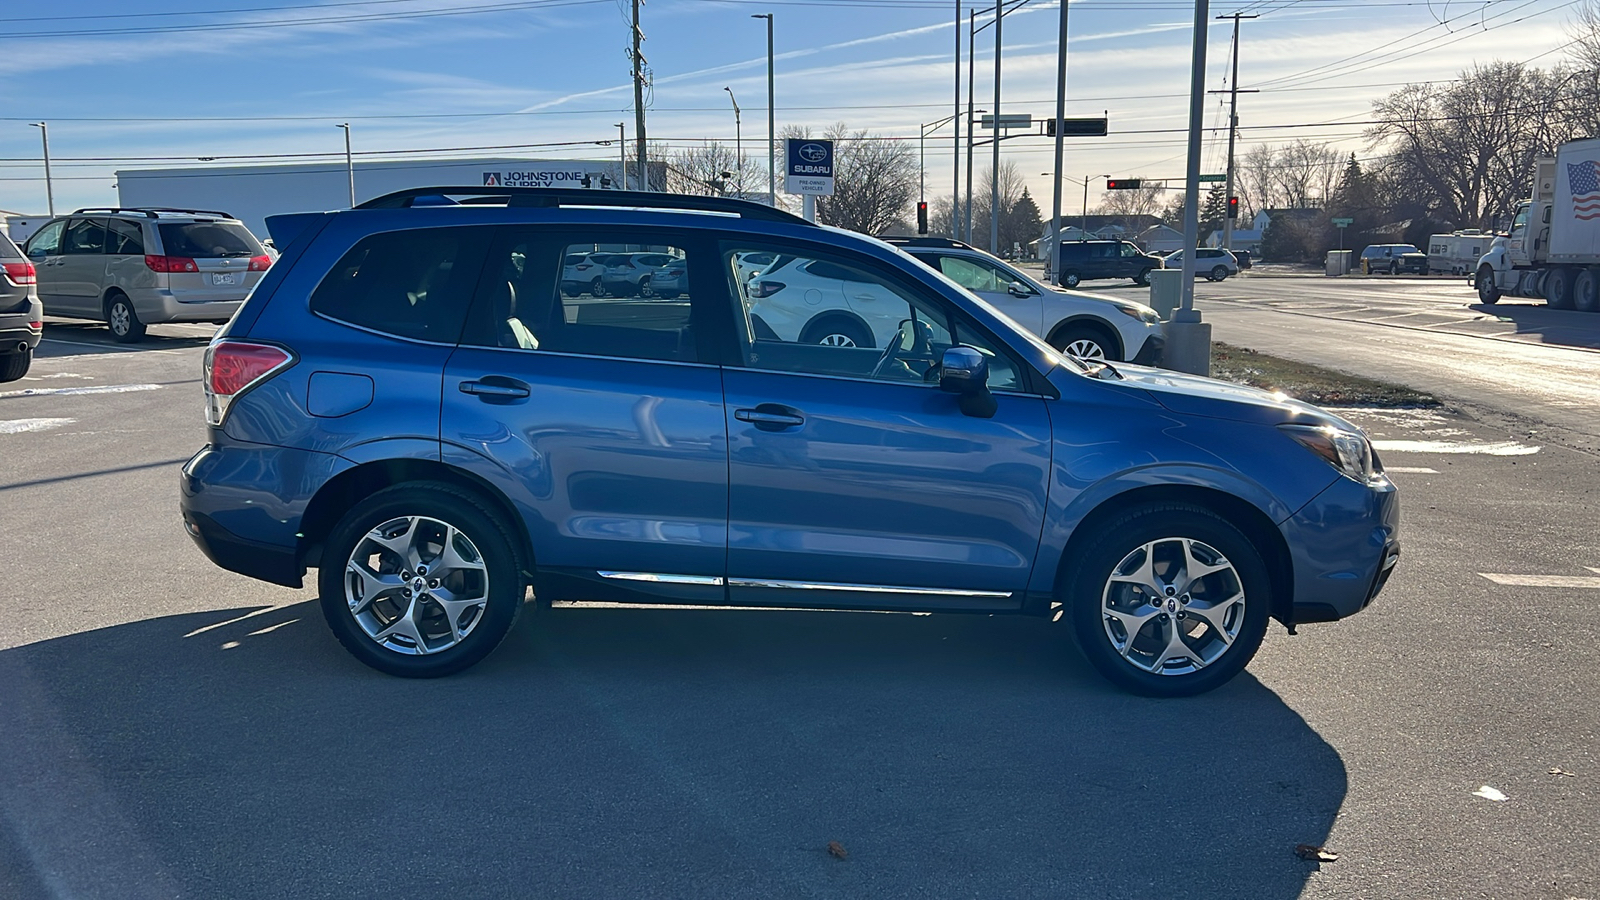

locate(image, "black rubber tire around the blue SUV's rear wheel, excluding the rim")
[[317, 482, 526, 677]]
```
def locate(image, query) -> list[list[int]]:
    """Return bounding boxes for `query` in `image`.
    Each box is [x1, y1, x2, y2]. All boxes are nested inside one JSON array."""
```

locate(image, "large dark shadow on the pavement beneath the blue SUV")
[[0, 602, 1346, 898]]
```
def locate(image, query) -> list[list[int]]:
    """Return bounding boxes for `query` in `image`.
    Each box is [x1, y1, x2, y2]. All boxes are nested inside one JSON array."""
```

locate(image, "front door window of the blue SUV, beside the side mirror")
[[722, 243, 1021, 391]]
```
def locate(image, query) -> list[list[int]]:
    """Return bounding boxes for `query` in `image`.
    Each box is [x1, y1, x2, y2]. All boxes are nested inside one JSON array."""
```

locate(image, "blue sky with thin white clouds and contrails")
[[0, 0, 1574, 213]]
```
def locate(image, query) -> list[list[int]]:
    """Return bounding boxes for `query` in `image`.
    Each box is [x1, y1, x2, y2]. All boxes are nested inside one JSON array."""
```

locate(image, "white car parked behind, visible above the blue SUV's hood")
[[883, 237, 1165, 365]]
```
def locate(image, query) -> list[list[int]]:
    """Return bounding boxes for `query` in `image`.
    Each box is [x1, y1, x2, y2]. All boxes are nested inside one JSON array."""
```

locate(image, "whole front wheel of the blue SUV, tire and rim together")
[[1062, 503, 1270, 697]]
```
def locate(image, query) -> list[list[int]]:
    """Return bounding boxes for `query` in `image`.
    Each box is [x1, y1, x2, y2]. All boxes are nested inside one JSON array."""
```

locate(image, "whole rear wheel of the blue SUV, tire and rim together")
[[317, 482, 525, 677]]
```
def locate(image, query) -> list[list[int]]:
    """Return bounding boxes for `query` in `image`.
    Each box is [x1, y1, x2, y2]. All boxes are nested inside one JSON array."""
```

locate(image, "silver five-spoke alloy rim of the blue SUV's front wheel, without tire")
[[1101, 538, 1245, 676]]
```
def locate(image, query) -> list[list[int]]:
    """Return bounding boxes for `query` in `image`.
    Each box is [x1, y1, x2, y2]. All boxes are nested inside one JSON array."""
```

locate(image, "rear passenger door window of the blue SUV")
[[464, 231, 698, 362]]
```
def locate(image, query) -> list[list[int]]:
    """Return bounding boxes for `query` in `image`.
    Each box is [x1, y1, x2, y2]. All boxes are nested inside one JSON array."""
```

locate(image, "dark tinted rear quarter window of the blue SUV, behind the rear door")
[[310, 227, 490, 343]]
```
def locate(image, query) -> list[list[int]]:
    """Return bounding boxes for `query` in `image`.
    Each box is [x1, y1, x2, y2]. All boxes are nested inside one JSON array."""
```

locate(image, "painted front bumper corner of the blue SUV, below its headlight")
[[1278, 477, 1400, 625]]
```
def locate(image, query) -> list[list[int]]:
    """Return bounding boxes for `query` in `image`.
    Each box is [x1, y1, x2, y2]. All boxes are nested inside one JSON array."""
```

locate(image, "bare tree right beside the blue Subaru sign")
[[781, 122, 917, 234]]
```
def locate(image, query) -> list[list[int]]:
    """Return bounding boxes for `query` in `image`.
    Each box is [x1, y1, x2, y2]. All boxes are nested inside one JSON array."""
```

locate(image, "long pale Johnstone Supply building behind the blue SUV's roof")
[[117, 157, 666, 237]]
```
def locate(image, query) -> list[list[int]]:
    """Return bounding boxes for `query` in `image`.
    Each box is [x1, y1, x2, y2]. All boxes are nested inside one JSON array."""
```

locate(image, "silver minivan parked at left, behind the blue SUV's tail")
[[26, 208, 272, 343]]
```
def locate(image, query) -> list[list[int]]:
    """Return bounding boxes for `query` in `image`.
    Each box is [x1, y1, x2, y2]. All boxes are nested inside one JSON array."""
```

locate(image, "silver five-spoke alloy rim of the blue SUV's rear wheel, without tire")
[[344, 516, 490, 657]]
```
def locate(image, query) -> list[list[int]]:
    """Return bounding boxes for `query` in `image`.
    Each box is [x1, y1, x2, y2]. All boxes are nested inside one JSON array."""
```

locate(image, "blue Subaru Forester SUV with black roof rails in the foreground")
[[181, 187, 1400, 695]]
